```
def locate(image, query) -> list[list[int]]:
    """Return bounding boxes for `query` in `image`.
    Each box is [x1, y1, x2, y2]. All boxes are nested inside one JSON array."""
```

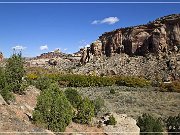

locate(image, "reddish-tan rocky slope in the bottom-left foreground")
[[0, 87, 53, 135]]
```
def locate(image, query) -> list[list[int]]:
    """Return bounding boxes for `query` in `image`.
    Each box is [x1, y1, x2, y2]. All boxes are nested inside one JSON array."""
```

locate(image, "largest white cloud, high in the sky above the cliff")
[[91, 17, 119, 25]]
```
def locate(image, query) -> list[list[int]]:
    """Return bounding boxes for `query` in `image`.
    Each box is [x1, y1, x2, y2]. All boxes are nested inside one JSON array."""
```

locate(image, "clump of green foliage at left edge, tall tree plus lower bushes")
[[0, 54, 27, 103]]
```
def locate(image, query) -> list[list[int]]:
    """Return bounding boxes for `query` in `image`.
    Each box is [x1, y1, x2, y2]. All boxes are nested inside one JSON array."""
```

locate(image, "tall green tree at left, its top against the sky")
[[5, 54, 25, 93]]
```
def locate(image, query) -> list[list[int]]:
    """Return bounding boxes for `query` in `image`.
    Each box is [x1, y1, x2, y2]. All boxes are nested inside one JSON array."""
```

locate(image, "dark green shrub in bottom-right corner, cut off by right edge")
[[166, 114, 180, 135]]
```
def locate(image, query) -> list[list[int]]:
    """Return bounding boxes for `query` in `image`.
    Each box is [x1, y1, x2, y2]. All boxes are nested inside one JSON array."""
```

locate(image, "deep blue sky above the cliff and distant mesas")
[[0, 0, 180, 57]]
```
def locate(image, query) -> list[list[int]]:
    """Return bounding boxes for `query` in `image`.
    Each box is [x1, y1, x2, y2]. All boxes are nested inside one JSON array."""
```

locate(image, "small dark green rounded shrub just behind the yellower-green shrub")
[[65, 88, 82, 108]]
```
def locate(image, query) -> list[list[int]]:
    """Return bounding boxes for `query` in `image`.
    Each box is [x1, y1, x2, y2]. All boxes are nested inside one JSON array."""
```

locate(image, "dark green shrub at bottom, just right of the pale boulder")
[[137, 114, 163, 135]]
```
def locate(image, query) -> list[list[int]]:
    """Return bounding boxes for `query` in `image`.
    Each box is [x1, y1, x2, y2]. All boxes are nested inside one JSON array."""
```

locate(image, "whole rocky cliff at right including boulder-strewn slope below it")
[[75, 14, 180, 81]]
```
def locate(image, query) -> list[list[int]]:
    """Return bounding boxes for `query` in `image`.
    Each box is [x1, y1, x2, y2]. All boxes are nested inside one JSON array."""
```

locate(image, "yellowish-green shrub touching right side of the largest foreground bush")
[[73, 98, 94, 124]]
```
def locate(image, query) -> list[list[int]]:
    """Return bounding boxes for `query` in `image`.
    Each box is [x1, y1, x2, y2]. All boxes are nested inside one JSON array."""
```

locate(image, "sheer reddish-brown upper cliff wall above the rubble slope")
[[97, 14, 180, 56]]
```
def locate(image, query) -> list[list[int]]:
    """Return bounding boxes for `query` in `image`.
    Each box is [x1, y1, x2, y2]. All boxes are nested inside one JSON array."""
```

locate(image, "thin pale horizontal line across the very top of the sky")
[[0, 1, 180, 4]]
